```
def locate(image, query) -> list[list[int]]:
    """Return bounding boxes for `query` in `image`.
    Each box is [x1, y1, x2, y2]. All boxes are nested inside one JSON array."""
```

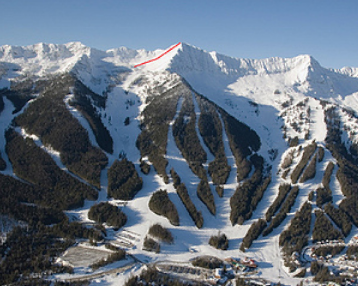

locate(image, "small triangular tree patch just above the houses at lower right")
[[312, 210, 343, 242]]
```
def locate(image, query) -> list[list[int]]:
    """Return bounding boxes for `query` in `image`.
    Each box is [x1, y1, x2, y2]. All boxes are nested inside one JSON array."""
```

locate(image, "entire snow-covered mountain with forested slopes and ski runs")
[[0, 42, 358, 284]]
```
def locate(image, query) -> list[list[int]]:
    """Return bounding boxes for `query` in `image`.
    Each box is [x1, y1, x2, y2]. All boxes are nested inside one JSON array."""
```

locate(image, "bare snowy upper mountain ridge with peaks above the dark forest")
[[0, 42, 358, 110]]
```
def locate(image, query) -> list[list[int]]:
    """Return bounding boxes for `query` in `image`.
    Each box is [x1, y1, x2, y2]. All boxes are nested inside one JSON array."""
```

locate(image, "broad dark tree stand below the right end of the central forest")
[[230, 154, 271, 225]]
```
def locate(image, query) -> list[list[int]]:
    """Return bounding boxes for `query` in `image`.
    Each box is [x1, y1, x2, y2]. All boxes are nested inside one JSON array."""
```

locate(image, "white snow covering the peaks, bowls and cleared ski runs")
[[0, 42, 358, 285]]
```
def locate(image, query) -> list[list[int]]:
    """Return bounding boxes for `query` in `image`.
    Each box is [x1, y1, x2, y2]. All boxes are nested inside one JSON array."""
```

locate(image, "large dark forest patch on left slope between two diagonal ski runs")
[[15, 75, 108, 188]]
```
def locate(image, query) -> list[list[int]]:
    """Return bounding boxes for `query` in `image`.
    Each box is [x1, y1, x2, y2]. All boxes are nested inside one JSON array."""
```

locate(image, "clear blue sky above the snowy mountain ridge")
[[0, 0, 358, 68]]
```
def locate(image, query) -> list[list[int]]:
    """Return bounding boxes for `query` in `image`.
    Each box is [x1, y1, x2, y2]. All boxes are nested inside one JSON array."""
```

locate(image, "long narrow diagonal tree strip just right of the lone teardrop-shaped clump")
[[170, 169, 204, 228]]
